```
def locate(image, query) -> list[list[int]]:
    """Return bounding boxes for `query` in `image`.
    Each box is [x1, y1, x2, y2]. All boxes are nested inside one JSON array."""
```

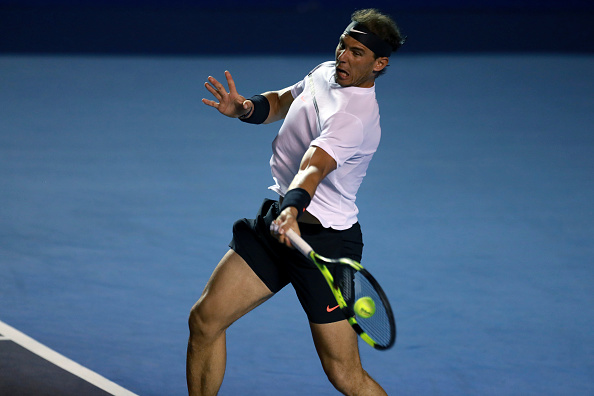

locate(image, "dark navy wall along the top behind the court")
[[0, 0, 594, 55]]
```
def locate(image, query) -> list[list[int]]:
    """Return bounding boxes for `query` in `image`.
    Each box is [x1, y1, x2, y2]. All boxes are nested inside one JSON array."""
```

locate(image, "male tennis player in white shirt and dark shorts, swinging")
[[186, 9, 403, 395]]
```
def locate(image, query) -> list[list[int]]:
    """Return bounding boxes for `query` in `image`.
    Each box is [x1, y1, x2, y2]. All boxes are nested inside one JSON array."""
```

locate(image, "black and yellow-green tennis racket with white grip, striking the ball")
[[285, 229, 396, 350]]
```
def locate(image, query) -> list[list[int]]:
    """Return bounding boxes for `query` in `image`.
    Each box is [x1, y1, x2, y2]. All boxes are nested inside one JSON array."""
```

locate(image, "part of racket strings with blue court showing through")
[[349, 271, 393, 346]]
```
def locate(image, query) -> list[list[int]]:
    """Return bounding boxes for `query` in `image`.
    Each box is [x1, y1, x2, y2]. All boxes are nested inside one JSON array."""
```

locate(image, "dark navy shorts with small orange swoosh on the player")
[[229, 199, 363, 324]]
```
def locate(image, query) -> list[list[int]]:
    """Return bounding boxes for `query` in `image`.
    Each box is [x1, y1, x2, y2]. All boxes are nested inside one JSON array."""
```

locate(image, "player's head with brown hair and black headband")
[[336, 9, 404, 88]]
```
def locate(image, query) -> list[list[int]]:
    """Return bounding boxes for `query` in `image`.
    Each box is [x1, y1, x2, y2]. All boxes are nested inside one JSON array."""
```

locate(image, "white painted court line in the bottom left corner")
[[0, 321, 137, 396]]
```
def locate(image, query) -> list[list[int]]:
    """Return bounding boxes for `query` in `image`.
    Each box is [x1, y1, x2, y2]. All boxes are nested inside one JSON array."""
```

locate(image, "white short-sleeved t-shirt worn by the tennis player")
[[269, 61, 381, 230]]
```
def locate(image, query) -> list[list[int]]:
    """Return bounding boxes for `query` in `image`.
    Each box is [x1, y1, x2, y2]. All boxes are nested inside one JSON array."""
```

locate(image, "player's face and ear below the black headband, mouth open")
[[335, 34, 388, 88]]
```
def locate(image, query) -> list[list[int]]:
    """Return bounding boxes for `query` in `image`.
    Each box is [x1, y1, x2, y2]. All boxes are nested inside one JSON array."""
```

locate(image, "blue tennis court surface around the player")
[[0, 54, 594, 396]]
